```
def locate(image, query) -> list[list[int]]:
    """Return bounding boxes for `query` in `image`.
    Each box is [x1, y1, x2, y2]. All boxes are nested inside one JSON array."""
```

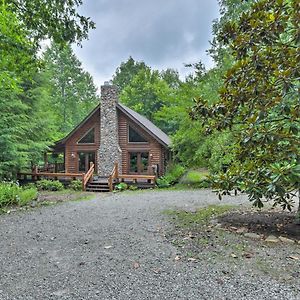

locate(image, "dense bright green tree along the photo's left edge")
[[0, 5, 46, 178]]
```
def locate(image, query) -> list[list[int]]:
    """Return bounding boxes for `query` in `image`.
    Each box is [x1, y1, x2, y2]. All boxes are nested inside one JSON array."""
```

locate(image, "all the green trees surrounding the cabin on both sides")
[[0, 0, 300, 216]]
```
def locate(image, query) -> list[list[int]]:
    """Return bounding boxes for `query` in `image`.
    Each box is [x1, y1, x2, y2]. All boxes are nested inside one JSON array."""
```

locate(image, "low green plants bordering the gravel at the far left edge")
[[0, 182, 37, 208]]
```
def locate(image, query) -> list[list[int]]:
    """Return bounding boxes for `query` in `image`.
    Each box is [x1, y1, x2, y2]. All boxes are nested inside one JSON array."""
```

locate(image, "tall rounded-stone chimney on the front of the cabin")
[[98, 82, 122, 176]]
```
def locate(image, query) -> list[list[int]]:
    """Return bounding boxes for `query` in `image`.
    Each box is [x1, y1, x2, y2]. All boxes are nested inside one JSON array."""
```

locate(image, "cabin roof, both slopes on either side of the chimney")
[[54, 103, 171, 148]]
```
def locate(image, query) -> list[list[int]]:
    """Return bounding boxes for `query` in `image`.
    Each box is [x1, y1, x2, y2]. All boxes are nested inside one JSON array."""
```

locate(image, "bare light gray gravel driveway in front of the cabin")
[[0, 190, 300, 300]]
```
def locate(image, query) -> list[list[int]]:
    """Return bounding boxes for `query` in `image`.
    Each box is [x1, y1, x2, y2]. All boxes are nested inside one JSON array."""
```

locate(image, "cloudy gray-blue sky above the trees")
[[74, 0, 219, 87]]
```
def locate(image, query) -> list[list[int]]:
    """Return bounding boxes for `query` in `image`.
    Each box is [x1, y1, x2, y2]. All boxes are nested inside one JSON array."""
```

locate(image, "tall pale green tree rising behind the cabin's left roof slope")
[[44, 43, 99, 135]]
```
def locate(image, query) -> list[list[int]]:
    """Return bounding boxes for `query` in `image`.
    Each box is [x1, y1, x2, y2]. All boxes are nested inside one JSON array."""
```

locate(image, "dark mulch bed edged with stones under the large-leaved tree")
[[218, 210, 300, 240]]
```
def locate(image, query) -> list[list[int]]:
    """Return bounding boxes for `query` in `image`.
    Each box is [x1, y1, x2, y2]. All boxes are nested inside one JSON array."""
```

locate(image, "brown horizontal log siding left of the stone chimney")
[[65, 110, 100, 173]]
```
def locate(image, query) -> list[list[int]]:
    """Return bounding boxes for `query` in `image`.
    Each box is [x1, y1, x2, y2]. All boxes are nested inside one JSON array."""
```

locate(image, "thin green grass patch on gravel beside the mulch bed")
[[165, 205, 235, 227]]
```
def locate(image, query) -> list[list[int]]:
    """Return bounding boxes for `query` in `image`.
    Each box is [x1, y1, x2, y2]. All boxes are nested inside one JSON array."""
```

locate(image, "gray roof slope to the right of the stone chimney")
[[117, 103, 171, 147]]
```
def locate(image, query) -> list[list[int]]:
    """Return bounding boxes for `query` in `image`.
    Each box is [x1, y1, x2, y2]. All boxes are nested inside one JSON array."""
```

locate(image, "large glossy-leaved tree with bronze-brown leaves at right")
[[192, 0, 300, 222]]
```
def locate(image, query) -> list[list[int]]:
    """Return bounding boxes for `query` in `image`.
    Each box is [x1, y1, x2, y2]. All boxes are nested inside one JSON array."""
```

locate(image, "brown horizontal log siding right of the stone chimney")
[[119, 112, 164, 175]]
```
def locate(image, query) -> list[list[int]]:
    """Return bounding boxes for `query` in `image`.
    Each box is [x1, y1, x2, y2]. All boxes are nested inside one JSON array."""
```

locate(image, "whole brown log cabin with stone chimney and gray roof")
[[44, 83, 171, 190]]
